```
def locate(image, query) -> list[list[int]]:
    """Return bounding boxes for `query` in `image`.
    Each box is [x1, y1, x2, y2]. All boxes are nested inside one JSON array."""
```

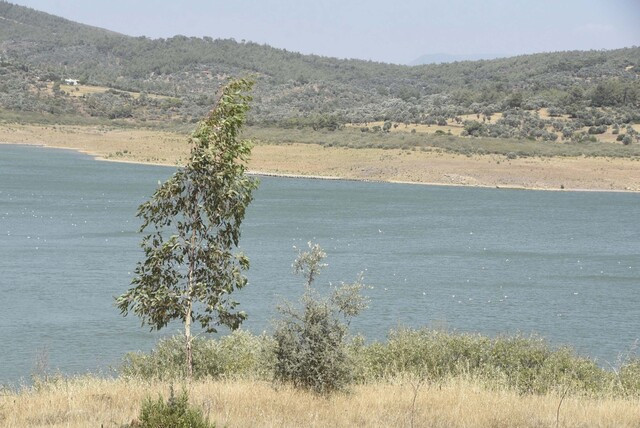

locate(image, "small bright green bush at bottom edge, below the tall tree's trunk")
[[131, 387, 215, 428]]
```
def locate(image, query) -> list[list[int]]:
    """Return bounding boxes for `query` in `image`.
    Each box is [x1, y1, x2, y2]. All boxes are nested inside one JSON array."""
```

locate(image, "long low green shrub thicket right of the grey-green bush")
[[354, 329, 616, 394]]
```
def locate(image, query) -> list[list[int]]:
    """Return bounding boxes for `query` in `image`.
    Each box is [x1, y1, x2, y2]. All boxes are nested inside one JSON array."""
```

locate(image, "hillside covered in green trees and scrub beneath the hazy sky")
[[0, 2, 640, 151]]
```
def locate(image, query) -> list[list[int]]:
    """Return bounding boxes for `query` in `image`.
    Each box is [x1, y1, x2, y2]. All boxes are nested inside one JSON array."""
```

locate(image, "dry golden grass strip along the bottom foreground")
[[0, 378, 640, 427]]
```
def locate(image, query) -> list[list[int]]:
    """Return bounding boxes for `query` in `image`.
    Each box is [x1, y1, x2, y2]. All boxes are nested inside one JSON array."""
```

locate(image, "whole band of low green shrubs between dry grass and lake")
[[120, 328, 640, 398]]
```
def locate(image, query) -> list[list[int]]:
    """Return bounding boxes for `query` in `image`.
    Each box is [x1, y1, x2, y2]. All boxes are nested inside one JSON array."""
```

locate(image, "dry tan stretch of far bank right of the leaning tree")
[[250, 144, 640, 191]]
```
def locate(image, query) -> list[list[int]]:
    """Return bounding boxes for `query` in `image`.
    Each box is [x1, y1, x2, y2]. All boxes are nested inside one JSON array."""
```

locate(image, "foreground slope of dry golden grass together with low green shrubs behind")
[[5, 330, 640, 427]]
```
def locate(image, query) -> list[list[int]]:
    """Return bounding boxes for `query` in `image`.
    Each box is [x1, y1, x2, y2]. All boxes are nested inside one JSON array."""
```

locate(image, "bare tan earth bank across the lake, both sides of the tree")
[[0, 124, 640, 192]]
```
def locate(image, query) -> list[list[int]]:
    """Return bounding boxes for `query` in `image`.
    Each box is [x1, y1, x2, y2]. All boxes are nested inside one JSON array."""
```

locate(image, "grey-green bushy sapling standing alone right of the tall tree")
[[274, 242, 366, 394]]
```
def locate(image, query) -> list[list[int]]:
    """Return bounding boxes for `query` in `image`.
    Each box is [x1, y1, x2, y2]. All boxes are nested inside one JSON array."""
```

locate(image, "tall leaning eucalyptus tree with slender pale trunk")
[[116, 79, 257, 377]]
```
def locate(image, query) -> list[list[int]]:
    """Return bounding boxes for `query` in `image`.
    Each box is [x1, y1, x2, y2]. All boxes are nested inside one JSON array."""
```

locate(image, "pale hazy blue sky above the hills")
[[10, 0, 640, 63]]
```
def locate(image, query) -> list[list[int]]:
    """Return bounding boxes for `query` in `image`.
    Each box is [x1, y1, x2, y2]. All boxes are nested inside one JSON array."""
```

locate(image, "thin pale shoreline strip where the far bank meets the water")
[[0, 141, 640, 193]]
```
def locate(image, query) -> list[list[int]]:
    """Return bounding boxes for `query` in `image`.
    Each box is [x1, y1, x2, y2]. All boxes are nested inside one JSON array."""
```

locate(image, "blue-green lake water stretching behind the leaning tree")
[[0, 145, 640, 384]]
